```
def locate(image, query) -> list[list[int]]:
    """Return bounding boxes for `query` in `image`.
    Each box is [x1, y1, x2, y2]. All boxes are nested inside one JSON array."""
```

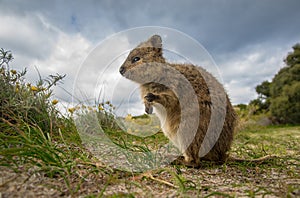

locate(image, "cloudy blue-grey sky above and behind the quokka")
[[0, 0, 300, 116]]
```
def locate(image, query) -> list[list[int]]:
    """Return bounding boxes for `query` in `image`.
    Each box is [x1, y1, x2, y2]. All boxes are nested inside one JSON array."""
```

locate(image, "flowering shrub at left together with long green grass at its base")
[[0, 49, 80, 168]]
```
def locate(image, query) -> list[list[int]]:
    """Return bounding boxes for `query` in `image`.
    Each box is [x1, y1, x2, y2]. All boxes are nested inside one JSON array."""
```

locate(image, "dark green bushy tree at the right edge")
[[250, 44, 300, 124]]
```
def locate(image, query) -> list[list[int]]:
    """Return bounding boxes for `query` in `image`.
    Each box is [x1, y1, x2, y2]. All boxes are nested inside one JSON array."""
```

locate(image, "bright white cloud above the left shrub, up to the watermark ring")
[[0, 13, 93, 107]]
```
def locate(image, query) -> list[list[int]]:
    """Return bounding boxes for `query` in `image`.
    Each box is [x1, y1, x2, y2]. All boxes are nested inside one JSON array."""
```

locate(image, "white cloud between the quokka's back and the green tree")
[[219, 44, 290, 104]]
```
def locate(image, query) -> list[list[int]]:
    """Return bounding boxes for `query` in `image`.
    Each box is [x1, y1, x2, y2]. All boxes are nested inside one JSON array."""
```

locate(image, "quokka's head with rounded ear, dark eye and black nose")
[[119, 35, 165, 77]]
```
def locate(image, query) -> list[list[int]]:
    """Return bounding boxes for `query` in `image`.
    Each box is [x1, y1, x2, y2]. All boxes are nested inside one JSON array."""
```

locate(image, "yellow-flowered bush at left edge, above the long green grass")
[[0, 49, 65, 133]]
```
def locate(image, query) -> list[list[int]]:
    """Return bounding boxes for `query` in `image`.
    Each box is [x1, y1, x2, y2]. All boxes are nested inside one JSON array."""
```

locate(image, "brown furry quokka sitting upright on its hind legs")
[[120, 35, 236, 165]]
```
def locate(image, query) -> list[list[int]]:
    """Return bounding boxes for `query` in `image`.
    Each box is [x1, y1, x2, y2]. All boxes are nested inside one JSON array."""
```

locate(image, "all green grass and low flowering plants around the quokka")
[[0, 49, 300, 197]]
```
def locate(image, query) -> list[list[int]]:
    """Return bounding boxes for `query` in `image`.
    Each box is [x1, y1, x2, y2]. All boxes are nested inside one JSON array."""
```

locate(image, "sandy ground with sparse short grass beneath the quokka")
[[0, 126, 300, 197]]
